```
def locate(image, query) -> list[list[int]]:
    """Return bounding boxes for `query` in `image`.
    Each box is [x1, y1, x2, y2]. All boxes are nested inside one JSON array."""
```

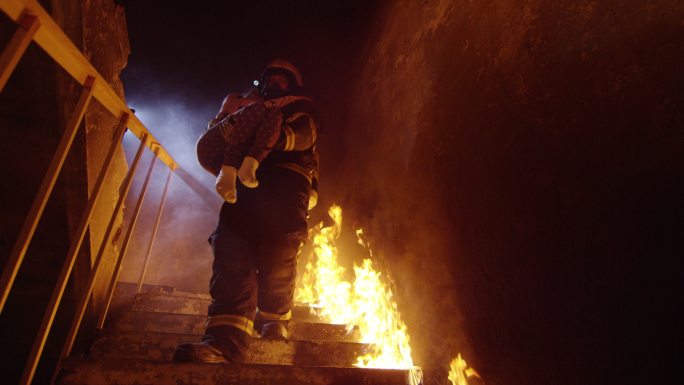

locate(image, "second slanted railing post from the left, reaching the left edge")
[[0, 76, 95, 313]]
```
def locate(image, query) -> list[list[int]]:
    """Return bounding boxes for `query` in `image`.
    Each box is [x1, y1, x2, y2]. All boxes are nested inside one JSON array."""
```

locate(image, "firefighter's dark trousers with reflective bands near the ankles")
[[207, 166, 311, 344]]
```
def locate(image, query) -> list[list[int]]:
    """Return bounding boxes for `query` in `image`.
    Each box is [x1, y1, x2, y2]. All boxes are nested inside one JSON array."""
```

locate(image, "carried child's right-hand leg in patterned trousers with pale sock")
[[238, 107, 283, 188]]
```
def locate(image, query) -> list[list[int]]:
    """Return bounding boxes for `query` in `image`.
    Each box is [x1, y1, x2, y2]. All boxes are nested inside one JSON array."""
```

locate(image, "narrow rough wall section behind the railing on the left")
[[52, 0, 130, 328]]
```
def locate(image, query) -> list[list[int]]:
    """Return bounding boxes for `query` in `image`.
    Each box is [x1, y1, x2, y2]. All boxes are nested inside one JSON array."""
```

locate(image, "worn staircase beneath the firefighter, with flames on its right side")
[[56, 284, 416, 385]]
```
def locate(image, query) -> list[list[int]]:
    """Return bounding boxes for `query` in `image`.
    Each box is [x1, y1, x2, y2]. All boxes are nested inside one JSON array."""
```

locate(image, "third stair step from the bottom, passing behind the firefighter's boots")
[[108, 311, 359, 342]]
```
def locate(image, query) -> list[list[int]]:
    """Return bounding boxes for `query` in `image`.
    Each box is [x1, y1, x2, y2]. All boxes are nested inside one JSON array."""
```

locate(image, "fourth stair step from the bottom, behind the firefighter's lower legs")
[[132, 289, 323, 322]]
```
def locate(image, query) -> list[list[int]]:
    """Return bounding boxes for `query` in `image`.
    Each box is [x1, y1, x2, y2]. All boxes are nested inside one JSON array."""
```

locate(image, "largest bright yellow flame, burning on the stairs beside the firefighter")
[[295, 205, 422, 384]]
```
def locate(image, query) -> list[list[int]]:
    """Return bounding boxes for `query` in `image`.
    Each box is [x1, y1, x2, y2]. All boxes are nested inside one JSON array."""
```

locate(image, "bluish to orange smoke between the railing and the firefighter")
[[121, 88, 220, 293]]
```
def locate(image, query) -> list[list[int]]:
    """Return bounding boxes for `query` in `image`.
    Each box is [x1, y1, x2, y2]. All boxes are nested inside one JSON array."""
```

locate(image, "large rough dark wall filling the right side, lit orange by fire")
[[326, 0, 684, 384]]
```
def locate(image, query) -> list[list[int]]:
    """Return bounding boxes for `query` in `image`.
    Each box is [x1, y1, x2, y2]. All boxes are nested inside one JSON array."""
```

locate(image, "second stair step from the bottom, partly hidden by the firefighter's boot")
[[90, 333, 369, 367]]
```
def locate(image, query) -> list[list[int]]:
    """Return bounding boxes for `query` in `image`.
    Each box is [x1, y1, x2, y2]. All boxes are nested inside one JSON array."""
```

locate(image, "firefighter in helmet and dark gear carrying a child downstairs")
[[174, 60, 319, 363]]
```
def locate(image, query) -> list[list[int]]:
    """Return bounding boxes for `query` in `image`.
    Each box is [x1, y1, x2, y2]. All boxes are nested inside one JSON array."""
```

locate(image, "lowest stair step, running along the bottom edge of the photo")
[[56, 358, 409, 385]]
